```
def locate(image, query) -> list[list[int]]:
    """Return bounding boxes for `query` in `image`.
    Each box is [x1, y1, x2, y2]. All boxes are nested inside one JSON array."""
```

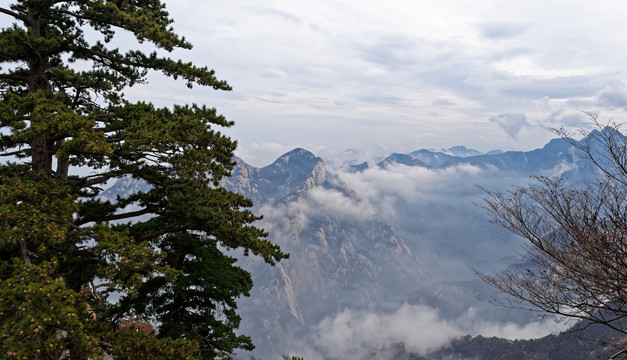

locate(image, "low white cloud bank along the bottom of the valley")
[[294, 304, 566, 360]]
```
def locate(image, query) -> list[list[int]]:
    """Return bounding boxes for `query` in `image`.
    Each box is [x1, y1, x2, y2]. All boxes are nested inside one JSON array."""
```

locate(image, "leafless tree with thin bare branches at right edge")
[[478, 115, 627, 335]]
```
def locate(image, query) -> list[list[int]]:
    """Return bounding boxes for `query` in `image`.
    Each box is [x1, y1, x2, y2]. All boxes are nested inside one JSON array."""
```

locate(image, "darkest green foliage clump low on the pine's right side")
[[123, 233, 253, 358]]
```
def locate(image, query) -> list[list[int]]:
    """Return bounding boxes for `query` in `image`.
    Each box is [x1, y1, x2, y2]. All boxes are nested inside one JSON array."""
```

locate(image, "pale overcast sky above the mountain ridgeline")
[[27, 0, 627, 165]]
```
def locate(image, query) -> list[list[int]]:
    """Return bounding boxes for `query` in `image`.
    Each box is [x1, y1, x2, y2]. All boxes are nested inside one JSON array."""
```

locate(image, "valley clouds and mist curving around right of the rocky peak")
[[239, 150, 571, 360]]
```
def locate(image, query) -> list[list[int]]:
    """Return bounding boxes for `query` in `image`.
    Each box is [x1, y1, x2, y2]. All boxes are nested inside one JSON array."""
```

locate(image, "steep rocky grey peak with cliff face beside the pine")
[[224, 149, 422, 357]]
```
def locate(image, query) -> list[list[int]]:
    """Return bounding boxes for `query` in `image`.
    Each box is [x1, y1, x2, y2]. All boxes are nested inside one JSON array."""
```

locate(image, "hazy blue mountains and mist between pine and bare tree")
[[103, 129, 620, 360]]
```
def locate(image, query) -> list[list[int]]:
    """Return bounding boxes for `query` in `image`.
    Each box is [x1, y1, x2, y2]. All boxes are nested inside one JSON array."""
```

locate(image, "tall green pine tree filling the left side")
[[0, 0, 287, 360]]
